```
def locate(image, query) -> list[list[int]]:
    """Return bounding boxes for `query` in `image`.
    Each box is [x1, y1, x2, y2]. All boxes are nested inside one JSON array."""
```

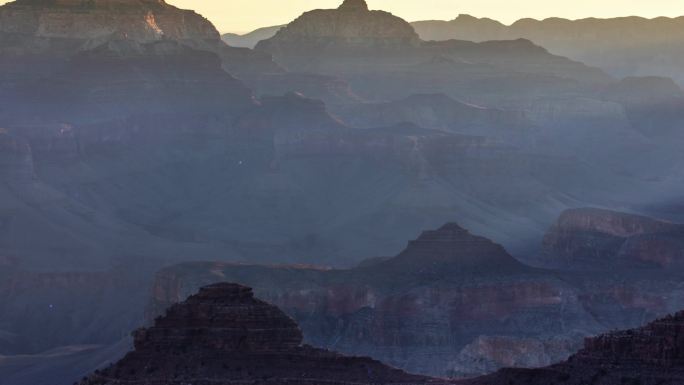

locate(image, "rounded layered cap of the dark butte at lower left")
[[135, 283, 303, 353]]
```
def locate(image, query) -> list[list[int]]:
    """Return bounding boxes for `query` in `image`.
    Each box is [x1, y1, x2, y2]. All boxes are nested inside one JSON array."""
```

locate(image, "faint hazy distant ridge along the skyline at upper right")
[[412, 15, 684, 84]]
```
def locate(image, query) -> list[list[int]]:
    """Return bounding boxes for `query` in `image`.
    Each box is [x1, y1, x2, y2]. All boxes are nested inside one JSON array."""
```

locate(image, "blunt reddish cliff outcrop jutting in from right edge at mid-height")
[[544, 209, 684, 270]]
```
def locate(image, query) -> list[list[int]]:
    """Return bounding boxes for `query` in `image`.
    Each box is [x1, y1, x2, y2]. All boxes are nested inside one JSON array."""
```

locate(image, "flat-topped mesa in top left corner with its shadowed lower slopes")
[[0, 0, 277, 85]]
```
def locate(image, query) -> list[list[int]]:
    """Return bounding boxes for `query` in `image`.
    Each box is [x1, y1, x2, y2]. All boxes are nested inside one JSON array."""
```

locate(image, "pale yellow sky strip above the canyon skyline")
[[0, 0, 684, 33]]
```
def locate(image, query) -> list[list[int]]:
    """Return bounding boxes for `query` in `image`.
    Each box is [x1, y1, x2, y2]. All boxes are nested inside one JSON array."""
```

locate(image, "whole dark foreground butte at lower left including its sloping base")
[[79, 283, 446, 385]]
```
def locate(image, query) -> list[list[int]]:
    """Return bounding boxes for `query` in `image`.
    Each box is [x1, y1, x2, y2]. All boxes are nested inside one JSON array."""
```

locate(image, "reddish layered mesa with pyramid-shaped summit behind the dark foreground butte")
[[144, 224, 602, 376]]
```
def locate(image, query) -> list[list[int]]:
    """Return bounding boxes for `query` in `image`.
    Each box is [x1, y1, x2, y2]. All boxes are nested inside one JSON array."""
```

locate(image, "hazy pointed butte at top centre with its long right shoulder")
[[255, 2, 612, 115]]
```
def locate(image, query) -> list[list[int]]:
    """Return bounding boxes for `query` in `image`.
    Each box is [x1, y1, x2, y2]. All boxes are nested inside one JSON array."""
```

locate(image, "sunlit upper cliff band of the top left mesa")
[[0, 0, 220, 50]]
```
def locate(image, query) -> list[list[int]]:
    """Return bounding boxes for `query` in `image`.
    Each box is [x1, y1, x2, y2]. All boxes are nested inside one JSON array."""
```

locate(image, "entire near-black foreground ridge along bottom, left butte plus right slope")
[[80, 283, 684, 385]]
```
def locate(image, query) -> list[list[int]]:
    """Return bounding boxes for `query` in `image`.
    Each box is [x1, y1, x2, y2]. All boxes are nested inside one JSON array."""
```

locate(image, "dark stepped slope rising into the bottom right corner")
[[463, 313, 684, 385]]
